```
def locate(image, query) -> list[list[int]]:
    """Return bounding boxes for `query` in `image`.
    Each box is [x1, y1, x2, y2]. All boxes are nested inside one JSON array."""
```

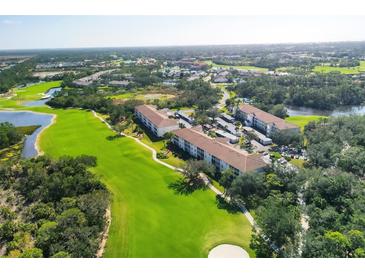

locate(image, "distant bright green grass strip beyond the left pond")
[[0, 81, 62, 108]]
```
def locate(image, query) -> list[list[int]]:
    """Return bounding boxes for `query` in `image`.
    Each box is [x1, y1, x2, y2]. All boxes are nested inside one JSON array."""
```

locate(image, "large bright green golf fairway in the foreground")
[[33, 108, 254, 257]]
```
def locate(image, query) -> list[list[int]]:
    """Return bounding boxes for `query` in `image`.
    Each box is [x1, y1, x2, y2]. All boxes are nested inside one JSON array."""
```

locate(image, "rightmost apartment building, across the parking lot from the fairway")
[[236, 104, 299, 136]]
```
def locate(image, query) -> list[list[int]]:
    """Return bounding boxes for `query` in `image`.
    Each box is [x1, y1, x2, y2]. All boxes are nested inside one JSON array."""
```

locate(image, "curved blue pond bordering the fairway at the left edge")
[[0, 111, 52, 158]]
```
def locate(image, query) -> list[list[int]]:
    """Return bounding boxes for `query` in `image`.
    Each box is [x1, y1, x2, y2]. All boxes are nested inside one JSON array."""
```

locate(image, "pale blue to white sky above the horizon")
[[0, 15, 365, 49]]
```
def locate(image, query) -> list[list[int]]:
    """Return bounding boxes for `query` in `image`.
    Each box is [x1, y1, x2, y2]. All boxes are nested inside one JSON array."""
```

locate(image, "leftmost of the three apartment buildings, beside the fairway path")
[[135, 105, 179, 137]]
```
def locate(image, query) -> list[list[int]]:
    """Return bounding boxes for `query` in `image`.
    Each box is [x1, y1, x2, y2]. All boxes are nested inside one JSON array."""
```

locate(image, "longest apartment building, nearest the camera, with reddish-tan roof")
[[172, 127, 266, 175]]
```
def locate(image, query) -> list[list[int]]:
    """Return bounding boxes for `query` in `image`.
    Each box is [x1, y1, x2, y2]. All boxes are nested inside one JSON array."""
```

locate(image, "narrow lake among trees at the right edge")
[[287, 106, 365, 116]]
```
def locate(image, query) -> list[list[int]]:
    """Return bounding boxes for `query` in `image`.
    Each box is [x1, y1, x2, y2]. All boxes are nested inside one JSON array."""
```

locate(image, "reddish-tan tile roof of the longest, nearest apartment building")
[[174, 128, 266, 172]]
